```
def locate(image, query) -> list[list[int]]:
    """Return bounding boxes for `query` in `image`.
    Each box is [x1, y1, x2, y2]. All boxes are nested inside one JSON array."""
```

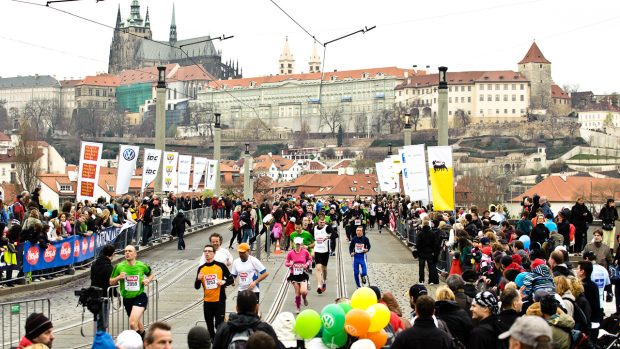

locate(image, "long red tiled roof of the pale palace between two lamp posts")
[[209, 67, 416, 89]]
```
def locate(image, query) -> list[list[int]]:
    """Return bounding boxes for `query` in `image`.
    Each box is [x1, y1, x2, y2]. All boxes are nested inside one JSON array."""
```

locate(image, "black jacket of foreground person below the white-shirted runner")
[[213, 313, 284, 349]]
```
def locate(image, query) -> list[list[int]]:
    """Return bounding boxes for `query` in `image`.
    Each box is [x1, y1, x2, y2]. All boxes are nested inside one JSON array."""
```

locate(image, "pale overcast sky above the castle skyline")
[[0, 0, 620, 93]]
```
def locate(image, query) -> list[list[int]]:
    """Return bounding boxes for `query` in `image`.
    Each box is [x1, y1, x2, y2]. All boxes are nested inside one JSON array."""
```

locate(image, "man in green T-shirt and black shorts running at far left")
[[110, 245, 155, 338]]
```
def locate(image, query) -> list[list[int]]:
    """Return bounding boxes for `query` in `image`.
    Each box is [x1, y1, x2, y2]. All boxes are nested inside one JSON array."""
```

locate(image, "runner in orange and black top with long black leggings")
[[194, 245, 235, 338]]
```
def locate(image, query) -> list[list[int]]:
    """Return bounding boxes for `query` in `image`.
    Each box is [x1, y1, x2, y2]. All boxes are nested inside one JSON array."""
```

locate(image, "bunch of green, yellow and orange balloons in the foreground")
[[295, 287, 390, 349]]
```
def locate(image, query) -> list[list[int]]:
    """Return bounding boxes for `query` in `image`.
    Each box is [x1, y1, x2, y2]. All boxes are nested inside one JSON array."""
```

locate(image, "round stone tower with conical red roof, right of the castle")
[[518, 42, 553, 109]]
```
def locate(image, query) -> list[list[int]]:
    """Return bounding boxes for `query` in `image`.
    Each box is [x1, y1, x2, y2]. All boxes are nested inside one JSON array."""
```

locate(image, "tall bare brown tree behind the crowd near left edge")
[[15, 120, 39, 190]]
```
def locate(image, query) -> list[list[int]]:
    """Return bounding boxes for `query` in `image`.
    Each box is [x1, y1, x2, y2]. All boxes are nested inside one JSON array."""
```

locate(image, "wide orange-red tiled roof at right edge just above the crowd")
[[512, 176, 620, 202]]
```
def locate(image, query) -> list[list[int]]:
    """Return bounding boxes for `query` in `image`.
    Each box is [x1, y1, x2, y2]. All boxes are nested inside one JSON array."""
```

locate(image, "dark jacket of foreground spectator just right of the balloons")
[[390, 317, 452, 349]]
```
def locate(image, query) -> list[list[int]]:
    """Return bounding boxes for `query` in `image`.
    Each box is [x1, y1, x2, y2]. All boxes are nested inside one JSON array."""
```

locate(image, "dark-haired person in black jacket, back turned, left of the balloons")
[[213, 290, 284, 349]]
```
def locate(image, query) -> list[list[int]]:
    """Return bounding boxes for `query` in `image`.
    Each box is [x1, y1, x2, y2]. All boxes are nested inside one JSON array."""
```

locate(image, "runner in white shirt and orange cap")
[[230, 243, 269, 302]]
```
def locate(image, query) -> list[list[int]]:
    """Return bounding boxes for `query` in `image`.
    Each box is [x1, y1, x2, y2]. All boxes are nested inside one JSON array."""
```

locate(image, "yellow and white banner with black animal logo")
[[428, 146, 454, 211]]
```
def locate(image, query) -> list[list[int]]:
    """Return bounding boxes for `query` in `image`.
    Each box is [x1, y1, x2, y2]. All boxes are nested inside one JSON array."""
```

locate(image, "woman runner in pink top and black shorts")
[[285, 237, 312, 314]]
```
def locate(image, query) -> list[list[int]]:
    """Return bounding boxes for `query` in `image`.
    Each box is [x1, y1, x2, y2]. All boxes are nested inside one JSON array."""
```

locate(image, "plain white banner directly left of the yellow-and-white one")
[[399, 144, 428, 205]]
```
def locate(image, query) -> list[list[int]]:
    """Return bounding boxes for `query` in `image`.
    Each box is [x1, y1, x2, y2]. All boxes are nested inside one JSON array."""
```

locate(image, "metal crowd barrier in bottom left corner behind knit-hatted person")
[[0, 298, 52, 349]]
